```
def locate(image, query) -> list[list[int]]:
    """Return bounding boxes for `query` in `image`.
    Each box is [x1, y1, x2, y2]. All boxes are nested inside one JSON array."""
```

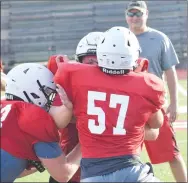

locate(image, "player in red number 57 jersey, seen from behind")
[[55, 27, 165, 182]]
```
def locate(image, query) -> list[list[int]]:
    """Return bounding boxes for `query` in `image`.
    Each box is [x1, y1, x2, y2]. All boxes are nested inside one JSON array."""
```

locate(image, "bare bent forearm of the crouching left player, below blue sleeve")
[[39, 144, 81, 182]]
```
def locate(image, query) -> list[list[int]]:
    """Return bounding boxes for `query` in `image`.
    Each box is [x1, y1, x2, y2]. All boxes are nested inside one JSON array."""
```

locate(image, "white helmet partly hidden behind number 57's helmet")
[[76, 32, 103, 62]]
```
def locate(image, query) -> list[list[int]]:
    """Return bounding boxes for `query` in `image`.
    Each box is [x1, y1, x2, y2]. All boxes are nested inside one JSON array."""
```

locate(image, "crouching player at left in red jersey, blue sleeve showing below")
[[1, 63, 81, 182]]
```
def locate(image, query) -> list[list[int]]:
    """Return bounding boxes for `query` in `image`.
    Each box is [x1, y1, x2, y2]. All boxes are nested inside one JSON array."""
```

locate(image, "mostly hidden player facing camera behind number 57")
[[47, 32, 106, 183]]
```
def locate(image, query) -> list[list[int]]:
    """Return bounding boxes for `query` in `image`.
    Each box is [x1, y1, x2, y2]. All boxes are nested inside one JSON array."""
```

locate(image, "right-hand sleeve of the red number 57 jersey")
[[144, 73, 165, 112]]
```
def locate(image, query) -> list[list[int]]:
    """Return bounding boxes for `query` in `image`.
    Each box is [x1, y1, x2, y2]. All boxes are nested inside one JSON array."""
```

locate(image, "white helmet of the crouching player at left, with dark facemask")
[[5, 63, 56, 111]]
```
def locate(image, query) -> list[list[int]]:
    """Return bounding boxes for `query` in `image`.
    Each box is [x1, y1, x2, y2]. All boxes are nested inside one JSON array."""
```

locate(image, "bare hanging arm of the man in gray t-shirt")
[[165, 66, 178, 122]]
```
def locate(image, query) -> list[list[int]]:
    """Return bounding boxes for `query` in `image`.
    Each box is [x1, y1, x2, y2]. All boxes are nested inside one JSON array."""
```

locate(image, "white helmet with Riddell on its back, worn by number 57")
[[97, 27, 140, 74]]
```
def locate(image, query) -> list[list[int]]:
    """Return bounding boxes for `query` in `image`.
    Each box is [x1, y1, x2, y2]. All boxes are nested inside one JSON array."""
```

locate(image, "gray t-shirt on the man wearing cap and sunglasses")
[[136, 28, 179, 78]]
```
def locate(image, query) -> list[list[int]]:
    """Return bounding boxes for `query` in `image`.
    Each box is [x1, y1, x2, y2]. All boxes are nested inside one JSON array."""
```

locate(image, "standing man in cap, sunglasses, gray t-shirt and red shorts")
[[125, 1, 187, 182]]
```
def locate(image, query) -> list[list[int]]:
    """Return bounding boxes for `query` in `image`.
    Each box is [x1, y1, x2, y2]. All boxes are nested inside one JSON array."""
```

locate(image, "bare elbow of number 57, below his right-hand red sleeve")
[[147, 110, 164, 129]]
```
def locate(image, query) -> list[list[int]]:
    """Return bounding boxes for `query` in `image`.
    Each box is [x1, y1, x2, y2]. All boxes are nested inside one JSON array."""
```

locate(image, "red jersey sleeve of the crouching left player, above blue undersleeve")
[[18, 103, 59, 142]]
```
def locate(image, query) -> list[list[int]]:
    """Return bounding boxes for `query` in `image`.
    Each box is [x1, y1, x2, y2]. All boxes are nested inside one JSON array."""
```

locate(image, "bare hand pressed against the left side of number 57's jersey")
[[56, 84, 73, 110]]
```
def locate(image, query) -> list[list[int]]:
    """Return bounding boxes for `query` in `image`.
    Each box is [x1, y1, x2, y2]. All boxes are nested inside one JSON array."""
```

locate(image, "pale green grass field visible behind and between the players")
[[1, 74, 187, 182]]
